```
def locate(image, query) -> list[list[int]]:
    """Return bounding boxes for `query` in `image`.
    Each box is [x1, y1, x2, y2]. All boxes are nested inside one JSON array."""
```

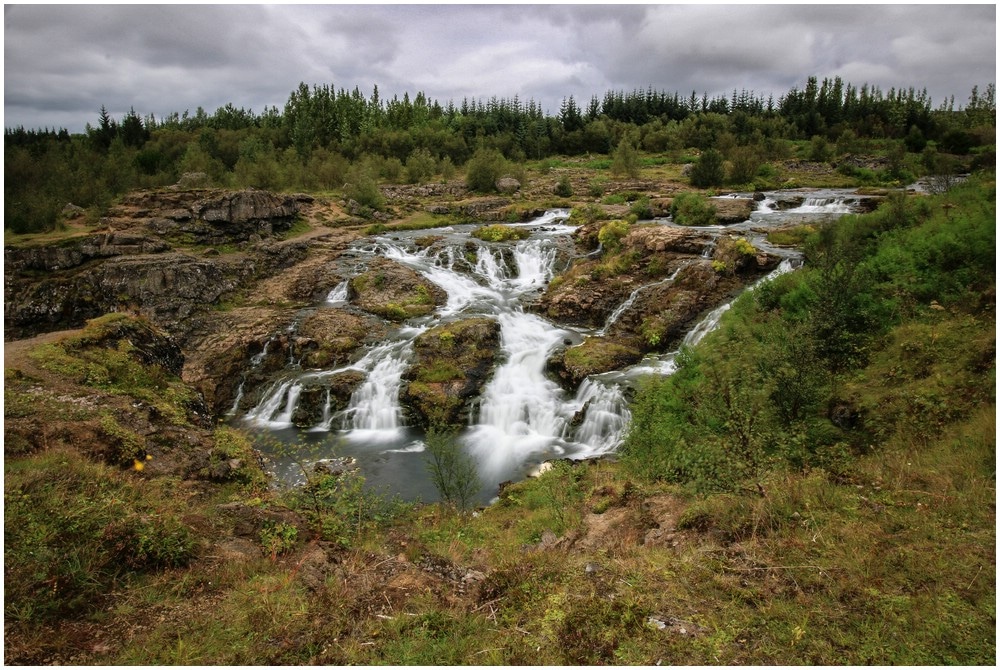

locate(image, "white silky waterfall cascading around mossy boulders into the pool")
[[242, 201, 836, 499]]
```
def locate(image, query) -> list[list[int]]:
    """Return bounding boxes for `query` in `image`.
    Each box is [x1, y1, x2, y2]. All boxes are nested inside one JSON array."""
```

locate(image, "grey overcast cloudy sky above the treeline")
[[4, 3, 996, 132]]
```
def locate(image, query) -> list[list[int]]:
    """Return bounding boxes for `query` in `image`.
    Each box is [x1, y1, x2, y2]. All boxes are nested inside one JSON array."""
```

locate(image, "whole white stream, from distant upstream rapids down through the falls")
[[233, 191, 859, 503]]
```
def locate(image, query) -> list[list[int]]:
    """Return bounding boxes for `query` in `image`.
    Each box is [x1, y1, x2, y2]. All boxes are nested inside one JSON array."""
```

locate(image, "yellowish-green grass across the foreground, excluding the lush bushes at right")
[[4, 159, 996, 665]]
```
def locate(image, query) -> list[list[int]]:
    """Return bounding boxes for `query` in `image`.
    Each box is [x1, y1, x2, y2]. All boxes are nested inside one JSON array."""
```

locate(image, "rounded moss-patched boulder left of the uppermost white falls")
[[348, 258, 448, 321]]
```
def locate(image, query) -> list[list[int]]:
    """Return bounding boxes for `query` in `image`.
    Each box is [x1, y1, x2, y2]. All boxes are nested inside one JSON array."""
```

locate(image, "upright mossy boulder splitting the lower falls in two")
[[401, 317, 500, 427]]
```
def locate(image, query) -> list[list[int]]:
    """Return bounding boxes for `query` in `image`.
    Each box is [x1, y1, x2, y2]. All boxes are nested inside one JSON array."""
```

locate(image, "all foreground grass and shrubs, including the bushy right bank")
[[4, 169, 996, 665]]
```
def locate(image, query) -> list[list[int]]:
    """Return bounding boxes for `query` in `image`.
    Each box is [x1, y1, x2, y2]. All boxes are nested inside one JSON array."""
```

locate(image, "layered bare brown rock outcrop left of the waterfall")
[[4, 190, 311, 340]]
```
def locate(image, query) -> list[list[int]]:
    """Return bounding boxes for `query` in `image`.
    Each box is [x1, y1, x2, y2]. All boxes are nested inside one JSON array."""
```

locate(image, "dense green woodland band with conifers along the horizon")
[[4, 77, 996, 232]]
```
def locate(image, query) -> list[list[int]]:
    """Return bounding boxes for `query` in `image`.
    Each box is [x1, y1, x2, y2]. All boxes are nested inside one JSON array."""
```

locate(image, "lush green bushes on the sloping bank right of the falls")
[[623, 181, 996, 490]]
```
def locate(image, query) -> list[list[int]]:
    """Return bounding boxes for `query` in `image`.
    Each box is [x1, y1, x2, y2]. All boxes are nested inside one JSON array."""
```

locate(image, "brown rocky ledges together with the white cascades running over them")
[[5, 187, 868, 502]]
